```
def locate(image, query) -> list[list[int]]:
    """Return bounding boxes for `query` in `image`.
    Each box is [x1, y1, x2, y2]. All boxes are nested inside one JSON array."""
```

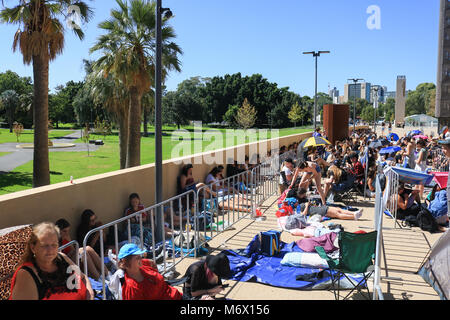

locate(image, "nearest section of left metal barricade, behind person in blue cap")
[[83, 190, 198, 299]]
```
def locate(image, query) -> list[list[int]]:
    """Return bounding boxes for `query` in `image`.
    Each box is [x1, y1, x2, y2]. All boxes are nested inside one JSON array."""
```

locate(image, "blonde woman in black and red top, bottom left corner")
[[10, 222, 94, 300]]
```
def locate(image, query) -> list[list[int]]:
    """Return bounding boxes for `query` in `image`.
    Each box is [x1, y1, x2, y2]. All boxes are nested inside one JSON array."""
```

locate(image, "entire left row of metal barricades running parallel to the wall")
[[80, 156, 280, 299]]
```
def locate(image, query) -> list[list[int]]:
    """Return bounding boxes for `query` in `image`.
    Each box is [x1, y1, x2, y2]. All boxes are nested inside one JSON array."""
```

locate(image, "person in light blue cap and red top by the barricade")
[[118, 243, 183, 300]]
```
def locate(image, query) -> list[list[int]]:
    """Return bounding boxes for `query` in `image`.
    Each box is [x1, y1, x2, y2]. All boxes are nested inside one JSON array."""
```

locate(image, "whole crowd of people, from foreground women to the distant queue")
[[10, 125, 448, 300]]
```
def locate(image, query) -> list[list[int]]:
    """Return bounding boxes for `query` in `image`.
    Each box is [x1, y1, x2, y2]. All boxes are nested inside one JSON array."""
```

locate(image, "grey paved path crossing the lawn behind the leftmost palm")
[[0, 130, 99, 172]]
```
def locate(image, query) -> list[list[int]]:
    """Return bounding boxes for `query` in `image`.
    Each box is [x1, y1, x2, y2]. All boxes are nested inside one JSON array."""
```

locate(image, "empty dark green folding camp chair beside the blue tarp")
[[315, 231, 377, 300]]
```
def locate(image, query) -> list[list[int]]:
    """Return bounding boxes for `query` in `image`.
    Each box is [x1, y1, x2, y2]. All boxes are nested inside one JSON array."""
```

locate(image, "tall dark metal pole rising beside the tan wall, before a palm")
[[155, 0, 163, 242]]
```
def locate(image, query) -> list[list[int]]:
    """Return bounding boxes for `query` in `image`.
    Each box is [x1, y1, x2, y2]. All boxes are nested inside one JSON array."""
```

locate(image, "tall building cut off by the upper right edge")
[[435, 0, 450, 127]]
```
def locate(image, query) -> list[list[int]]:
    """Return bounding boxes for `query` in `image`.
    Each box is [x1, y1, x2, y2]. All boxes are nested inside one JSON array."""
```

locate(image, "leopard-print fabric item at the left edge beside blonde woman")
[[0, 225, 32, 300]]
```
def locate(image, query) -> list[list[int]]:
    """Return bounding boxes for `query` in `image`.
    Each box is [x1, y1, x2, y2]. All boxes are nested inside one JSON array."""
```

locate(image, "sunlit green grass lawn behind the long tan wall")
[[0, 128, 311, 194]]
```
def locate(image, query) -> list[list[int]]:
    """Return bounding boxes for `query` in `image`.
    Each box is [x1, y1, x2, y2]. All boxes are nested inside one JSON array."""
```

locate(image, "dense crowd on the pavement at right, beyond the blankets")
[[279, 128, 449, 231]]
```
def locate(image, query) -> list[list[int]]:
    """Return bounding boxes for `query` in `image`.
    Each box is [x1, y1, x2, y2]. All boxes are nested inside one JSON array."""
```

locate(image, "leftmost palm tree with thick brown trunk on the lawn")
[[0, 0, 92, 187]]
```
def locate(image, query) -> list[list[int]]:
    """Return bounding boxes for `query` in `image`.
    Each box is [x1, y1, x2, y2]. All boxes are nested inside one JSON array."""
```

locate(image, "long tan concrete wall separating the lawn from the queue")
[[0, 132, 312, 234]]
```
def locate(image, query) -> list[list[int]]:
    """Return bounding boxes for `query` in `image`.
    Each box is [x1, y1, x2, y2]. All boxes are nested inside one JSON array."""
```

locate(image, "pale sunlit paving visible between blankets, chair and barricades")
[[171, 192, 442, 300]]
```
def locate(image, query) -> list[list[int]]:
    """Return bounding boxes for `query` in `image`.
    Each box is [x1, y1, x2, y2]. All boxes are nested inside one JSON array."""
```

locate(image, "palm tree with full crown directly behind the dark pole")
[[91, 0, 182, 168]]
